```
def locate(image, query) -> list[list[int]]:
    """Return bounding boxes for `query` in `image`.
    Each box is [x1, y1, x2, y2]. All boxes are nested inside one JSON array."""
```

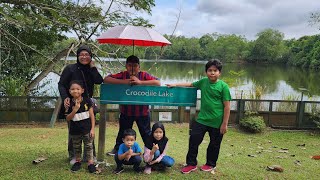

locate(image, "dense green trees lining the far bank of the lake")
[[125, 29, 320, 69]]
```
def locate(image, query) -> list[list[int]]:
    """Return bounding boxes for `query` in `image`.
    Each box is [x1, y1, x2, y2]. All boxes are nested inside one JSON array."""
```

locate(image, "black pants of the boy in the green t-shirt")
[[187, 121, 223, 167]]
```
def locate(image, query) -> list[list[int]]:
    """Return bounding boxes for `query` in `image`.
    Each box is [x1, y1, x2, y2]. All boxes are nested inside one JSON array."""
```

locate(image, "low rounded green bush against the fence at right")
[[240, 115, 266, 133]]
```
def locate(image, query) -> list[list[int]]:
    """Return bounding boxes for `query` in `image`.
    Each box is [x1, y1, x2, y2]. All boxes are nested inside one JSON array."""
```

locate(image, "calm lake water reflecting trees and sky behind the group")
[[44, 60, 320, 101]]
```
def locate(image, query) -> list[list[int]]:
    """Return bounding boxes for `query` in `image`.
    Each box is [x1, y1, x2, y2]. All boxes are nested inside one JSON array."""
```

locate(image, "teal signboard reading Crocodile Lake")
[[100, 84, 197, 106]]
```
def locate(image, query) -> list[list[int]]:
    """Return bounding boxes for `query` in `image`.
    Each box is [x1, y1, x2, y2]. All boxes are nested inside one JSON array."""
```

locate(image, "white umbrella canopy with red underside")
[[97, 25, 171, 46]]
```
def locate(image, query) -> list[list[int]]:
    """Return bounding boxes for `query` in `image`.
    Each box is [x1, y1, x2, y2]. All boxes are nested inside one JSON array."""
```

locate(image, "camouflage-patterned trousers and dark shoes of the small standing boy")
[[71, 133, 96, 173]]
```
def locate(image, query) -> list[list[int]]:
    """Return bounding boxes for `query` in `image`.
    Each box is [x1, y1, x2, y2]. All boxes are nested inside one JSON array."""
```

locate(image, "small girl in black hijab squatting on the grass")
[[144, 122, 174, 174]]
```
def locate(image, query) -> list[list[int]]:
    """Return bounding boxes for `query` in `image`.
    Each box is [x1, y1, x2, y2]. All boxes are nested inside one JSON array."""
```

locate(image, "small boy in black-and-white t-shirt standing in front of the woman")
[[66, 81, 96, 173]]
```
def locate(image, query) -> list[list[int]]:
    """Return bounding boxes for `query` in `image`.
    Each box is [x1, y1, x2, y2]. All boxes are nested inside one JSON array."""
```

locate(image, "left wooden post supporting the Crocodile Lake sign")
[[97, 104, 108, 162]]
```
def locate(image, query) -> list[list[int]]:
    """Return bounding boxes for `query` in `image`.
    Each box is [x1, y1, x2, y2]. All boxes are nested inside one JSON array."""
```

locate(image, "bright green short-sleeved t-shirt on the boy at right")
[[192, 77, 231, 128]]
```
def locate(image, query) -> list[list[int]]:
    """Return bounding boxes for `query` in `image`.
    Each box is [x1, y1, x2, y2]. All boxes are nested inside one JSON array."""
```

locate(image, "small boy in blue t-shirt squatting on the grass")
[[113, 129, 142, 174]]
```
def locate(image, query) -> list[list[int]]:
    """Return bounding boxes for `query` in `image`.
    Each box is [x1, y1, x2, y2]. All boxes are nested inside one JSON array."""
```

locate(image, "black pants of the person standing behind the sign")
[[114, 113, 151, 151]]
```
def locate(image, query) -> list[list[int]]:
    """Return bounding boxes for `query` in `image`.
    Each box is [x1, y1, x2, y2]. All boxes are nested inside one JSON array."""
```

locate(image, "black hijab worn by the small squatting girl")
[[145, 122, 169, 154]]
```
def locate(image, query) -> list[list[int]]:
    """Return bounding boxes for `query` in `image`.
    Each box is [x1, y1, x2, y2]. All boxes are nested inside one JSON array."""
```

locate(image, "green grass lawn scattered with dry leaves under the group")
[[0, 123, 320, 179]]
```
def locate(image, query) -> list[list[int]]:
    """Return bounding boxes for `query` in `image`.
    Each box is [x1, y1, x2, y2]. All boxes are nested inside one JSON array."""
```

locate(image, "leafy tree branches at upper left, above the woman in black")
[[0, 0, 155, 94]]
